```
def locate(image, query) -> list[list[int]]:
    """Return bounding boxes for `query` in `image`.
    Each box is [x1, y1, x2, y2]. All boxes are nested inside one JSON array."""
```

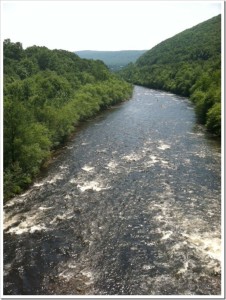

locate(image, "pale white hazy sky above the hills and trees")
[[1, 0, 223, 51]]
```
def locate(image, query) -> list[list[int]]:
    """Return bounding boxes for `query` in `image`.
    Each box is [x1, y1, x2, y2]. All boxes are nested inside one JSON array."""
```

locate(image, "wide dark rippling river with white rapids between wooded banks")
[[4, 86, 221, 295]]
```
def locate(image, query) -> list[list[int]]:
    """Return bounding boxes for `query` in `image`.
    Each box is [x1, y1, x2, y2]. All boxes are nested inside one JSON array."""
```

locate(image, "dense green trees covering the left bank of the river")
[[3, 39, 132, 199]]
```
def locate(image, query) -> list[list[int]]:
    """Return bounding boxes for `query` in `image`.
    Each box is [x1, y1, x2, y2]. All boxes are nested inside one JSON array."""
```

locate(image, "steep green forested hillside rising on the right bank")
[[121, 15, 221, 135]]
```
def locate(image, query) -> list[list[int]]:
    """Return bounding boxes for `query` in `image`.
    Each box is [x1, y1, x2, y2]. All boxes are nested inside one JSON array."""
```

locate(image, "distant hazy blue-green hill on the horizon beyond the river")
[[75, 50, 146, 71]]
